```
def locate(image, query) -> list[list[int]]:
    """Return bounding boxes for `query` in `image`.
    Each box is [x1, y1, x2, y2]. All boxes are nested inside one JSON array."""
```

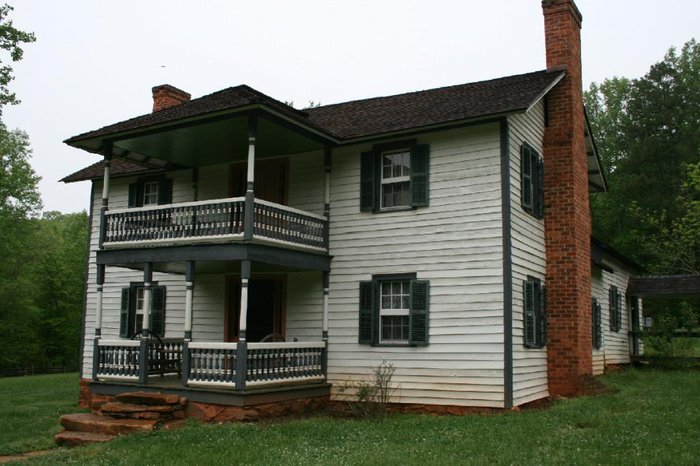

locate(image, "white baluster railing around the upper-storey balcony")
[[101, 197, 328, 250]]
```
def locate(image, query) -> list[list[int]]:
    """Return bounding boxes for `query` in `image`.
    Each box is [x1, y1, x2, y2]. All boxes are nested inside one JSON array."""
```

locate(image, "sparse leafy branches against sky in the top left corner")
[[0, 4, 36, 115]]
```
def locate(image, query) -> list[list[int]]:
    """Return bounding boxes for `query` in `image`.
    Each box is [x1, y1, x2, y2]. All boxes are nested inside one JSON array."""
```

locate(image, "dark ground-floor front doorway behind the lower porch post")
[[225, 275, 286, 341]]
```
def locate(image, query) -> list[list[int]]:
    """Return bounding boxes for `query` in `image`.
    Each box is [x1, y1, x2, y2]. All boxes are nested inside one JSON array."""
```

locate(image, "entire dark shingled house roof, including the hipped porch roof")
[[63, 70, 564, 182]]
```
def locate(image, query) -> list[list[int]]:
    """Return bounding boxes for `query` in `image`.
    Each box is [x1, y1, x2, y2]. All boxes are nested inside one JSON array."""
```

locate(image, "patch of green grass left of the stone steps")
[[0, 373, 78, 455]]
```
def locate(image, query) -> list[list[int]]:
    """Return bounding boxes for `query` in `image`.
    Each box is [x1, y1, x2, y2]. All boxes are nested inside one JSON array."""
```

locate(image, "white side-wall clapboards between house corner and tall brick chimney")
[[508, 102, 549, 406]]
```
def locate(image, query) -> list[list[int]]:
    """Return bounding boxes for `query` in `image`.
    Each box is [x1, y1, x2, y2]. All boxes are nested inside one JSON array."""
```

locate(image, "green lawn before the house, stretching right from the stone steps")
[[0, 369, 700, 465]]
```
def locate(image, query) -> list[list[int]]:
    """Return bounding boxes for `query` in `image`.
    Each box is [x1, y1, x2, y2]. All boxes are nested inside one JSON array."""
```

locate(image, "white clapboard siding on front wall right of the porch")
[[328, 124, 504, 407]]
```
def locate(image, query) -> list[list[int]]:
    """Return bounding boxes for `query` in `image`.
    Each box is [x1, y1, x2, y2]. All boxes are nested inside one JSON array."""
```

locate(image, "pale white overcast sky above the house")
[[2, 0, 700, 212]]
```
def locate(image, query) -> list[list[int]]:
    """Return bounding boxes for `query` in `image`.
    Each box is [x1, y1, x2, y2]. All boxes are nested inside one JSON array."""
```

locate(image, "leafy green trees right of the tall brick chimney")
[[585, 40, 700, 273]]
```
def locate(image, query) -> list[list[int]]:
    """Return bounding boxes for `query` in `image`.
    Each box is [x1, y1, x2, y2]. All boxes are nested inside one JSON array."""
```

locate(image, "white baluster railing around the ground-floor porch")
[[93, 339, 327, 391]]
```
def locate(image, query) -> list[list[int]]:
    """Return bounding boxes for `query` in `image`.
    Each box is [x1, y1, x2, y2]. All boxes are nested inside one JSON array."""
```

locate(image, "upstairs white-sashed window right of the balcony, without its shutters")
[[381, 148, 411, 209]]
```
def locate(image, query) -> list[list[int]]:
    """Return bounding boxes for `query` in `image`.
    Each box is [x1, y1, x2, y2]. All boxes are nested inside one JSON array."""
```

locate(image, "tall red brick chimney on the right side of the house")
[[542, 0, 592, 396]]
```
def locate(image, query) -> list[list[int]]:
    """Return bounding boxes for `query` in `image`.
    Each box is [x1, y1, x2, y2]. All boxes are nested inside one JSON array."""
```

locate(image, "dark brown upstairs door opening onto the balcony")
[[229, 158, 289, 205]]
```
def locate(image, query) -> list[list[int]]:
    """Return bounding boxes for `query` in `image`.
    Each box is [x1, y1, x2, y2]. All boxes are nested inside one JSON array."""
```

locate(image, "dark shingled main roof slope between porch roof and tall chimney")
[[306, 71, 562, 139]]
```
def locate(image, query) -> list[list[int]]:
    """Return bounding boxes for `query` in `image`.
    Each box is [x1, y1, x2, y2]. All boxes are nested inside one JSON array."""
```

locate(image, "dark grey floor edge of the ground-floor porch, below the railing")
[[90, 375, 331, 406]]
